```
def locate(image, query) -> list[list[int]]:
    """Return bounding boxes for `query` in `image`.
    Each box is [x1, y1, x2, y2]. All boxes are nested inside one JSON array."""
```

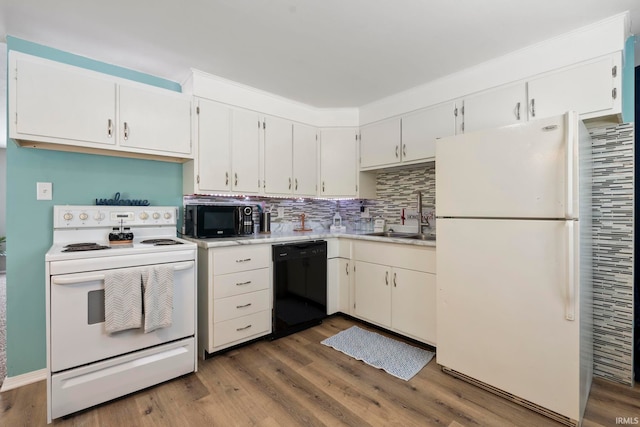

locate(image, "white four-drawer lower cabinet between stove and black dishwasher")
[[198, 245, 273, 356]]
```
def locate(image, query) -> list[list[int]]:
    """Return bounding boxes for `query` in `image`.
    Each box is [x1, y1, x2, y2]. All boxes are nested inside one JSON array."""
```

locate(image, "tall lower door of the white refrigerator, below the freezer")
[[437, 219, 588, 420]]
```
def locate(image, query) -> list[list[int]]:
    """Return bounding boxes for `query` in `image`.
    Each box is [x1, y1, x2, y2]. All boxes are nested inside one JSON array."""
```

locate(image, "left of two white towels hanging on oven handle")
[[104, 268, 142, 334]]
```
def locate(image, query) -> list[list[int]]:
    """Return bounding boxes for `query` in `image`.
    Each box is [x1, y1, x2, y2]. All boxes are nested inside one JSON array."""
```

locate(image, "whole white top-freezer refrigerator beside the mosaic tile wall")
[[436, 112, 593, 425]]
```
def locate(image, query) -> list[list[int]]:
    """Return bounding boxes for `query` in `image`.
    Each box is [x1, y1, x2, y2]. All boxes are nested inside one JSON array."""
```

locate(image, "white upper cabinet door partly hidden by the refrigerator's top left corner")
[[402, 103, 455, 162]]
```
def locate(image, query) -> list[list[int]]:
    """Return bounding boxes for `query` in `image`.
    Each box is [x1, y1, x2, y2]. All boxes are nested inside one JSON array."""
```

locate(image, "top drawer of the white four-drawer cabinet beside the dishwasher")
[[213, 245, 271, 275]]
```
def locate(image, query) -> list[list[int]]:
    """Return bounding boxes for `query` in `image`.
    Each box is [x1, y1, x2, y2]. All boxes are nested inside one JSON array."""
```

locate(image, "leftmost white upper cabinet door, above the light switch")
[[9, 59, 116, 146]]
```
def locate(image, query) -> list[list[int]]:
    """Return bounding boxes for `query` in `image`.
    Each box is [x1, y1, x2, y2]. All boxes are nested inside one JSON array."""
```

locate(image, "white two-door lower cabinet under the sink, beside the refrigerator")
[[353, 242, 436, 346]]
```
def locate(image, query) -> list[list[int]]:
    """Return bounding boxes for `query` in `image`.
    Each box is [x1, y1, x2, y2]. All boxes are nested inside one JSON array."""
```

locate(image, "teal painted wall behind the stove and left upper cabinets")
[[6, 37, 182, 377]]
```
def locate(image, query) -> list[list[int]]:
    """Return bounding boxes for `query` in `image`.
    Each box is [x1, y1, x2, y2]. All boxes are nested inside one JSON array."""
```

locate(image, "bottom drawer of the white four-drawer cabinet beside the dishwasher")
[[213, 310, 271, 347]]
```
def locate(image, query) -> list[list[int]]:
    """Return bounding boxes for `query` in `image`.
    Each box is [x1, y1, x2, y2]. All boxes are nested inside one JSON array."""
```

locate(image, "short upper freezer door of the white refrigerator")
[[436, 113, 579, 218]]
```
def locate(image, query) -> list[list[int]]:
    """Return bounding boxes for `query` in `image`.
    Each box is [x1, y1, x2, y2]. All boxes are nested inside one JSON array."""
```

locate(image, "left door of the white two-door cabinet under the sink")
[[355, 261, 392, 327]]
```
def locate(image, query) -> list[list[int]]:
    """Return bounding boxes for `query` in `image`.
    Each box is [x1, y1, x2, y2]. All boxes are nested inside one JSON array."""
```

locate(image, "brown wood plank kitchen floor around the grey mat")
[[0, 316, 640, 427]]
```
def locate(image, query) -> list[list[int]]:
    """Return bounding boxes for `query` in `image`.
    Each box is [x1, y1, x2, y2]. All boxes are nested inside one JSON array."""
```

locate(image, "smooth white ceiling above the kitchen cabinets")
[[0, 0, 640, 107]]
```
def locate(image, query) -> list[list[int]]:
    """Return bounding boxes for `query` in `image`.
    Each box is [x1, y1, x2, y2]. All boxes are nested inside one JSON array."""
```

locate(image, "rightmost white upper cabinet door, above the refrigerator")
[[527, 57, 620, 119]]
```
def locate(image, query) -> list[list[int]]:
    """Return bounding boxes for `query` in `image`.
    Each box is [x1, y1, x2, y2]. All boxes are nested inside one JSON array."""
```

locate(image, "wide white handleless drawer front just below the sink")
[[353, 242, 436, 273]]
